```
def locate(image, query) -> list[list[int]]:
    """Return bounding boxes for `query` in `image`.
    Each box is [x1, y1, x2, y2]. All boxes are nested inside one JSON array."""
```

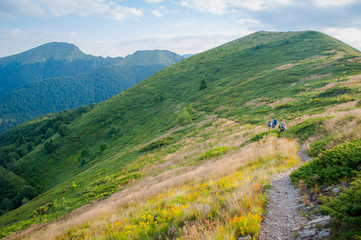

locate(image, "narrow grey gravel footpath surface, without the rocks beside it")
[[258, 145, 311, 240]]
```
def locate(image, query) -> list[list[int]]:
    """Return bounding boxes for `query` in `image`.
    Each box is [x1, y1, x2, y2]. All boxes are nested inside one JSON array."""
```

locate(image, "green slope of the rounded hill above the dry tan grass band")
[[0, 31, 361, 238]]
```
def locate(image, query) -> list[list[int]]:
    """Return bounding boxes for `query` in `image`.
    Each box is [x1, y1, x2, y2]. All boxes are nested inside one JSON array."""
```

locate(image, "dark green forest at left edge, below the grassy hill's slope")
[[0, 105, 94, 215]]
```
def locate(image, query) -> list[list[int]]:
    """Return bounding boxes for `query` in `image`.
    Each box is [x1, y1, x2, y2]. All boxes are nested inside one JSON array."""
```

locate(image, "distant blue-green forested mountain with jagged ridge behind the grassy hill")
[[0, 42, 183, 132]]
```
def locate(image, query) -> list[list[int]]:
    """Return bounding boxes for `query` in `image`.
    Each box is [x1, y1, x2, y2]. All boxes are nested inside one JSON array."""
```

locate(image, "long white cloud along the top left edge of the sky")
[[1, 0, 143, 20]]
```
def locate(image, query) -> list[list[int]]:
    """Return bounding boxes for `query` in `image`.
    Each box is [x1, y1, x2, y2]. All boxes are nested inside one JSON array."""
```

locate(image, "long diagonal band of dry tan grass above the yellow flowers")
[[12, 133, 298, 239]]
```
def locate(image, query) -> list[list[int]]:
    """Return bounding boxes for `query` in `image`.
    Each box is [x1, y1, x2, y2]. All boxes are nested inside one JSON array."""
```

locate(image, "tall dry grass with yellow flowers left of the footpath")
[[46, 137, 297, 239]]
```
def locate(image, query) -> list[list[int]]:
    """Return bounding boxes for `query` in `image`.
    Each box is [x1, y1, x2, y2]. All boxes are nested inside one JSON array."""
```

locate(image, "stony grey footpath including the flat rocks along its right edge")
[[258, 148, 331, 240]]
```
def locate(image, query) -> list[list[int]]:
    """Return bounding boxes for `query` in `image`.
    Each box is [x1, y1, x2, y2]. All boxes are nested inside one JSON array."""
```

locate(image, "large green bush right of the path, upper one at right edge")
[[290, 141, 361, 187]]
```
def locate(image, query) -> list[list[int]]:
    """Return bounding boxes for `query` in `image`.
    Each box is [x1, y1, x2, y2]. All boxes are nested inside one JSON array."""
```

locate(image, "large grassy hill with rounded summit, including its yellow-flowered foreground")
[[0, 31, 361, 239]]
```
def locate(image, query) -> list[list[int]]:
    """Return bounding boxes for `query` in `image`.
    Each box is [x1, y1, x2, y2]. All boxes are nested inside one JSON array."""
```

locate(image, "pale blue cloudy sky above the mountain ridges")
[[0, 0, 361, 57]]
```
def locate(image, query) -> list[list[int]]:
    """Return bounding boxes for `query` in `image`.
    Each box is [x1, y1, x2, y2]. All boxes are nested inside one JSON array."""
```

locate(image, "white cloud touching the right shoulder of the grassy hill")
[[321, 27, 361, 50]]
